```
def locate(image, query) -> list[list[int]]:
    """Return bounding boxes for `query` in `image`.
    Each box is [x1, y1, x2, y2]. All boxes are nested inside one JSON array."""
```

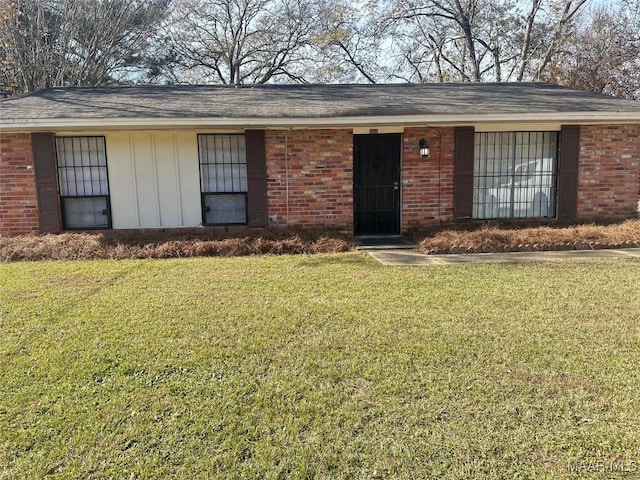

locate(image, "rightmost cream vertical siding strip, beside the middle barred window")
[[175, 132, 202, 227]]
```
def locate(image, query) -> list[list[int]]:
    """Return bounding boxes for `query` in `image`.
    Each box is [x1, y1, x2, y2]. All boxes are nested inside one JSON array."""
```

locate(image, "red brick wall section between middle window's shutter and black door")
[[265, 130, 353, 231]]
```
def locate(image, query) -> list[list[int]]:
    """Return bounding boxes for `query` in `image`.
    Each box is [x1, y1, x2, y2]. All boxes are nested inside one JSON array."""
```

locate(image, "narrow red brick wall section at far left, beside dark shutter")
[[0, 133, 40, 235]]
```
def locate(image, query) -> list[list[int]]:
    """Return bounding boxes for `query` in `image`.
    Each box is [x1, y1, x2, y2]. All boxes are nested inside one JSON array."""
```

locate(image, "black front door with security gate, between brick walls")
[[353, 133, 401, 235]]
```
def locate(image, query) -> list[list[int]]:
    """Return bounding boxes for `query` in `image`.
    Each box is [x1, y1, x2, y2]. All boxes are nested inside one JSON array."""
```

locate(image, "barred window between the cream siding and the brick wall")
[[198, 134, 247, 225]]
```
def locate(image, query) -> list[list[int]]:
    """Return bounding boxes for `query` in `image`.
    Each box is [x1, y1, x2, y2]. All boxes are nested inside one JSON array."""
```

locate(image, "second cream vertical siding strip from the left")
[[133, 132, 160, 228]]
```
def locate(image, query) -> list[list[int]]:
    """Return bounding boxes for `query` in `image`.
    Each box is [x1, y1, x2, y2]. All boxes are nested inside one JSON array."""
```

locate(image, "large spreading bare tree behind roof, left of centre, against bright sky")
[[157, 0, 324, 84]]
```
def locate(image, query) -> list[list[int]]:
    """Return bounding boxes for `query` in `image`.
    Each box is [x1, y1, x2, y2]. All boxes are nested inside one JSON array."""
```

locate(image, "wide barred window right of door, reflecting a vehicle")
[[473, 132, 558, 219]]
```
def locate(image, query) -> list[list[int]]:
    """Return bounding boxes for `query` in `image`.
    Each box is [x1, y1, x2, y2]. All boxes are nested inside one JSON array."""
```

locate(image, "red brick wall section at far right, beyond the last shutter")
[[578, 125, 640, 219]]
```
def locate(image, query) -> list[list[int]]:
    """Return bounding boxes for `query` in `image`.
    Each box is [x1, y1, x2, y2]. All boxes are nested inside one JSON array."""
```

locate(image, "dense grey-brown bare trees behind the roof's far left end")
[[0, 0, 168, 93]]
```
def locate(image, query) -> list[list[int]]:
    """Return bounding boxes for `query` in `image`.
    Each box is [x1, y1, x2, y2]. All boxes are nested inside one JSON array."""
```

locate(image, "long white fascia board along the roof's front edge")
[[0, 111, 640, 131]]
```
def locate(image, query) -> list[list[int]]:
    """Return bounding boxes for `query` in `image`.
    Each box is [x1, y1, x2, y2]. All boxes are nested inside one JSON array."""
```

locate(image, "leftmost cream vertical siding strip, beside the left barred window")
[[106, 132, 140, 228]]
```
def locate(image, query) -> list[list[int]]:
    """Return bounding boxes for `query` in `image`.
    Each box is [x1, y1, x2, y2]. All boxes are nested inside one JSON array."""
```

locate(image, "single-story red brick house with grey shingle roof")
[[0, 83, 640, 235]]
